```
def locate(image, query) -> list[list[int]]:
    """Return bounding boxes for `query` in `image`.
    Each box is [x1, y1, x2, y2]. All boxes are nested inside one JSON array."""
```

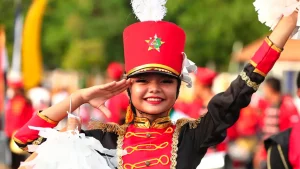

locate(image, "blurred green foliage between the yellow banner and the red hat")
[[43, 0, 132, 72]]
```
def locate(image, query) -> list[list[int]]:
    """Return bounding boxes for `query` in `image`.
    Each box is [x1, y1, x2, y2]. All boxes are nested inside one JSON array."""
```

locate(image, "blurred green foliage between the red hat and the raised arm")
[[168, 0, 268, 70]]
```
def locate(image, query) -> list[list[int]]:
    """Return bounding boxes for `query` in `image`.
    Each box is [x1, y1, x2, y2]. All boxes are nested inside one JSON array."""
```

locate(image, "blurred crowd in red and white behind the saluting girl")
[[4, 62, 300, 169]]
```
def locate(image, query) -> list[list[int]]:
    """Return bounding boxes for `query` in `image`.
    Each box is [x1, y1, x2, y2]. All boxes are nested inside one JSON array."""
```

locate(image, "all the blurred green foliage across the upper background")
[[0, 0, 268, 73]]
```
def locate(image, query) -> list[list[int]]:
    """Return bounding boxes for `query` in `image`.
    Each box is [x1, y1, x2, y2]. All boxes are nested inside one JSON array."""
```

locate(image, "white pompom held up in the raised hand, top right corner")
[[253, 0, 300, 38]]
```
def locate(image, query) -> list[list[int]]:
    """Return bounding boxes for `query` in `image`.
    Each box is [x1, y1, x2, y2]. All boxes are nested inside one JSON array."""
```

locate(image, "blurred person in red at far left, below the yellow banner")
[[4, 77, 34, 169]]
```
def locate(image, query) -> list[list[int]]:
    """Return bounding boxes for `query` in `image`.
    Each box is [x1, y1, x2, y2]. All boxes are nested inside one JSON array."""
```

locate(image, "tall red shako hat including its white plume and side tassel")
[[123, 0, 197, 86]]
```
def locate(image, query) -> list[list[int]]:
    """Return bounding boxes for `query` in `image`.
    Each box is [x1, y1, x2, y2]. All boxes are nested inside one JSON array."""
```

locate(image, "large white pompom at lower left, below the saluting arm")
[[21, 127, 126, 169]]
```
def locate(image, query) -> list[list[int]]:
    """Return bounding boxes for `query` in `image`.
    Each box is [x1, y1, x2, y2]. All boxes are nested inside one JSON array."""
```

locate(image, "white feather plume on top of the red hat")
[[131, 0, 167, 22]]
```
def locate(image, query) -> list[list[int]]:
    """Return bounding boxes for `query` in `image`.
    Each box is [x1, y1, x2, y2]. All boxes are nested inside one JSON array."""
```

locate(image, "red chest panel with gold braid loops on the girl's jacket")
[[122, 125, 175, 169]]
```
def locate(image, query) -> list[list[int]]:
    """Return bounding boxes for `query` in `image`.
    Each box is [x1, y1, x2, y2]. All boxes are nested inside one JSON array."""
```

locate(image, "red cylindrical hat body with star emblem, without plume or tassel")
[[123, 21, 185, 76]]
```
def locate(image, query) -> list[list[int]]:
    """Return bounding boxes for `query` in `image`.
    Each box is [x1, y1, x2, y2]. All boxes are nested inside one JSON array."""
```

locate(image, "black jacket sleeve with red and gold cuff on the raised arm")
[[180, 38, 282, 149]]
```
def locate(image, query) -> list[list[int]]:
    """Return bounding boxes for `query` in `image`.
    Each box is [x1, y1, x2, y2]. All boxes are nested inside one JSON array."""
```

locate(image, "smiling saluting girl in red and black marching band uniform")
[[14, 0, 298, 169]]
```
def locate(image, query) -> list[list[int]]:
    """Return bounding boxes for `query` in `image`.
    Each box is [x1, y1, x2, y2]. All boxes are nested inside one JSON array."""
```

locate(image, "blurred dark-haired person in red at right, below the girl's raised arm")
[[256, 77, 299, 168]]
